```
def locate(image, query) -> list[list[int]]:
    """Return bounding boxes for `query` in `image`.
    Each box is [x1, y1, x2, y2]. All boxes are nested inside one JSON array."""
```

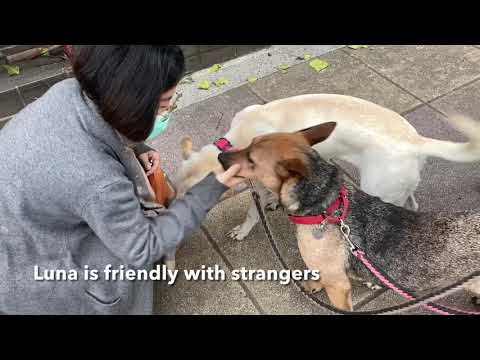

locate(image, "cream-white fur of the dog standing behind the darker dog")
[[175, 94, 480, 240]]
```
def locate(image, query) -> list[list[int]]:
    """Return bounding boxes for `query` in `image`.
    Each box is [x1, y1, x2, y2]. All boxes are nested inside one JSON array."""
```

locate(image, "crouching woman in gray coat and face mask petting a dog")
[[0, 45, 240, 314]]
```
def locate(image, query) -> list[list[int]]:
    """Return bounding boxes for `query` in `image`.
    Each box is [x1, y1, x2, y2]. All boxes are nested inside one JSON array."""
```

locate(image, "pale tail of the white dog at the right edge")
[[420, 115, 480, 162]]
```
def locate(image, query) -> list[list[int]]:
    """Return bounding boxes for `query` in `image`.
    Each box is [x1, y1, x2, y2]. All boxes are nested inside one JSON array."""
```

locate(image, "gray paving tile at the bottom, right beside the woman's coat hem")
[[154, 232, 258, 315]]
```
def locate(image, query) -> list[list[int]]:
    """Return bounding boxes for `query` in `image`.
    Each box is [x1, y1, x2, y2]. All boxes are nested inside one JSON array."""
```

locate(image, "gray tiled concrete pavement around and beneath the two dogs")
[[152, 46, 480, 314]]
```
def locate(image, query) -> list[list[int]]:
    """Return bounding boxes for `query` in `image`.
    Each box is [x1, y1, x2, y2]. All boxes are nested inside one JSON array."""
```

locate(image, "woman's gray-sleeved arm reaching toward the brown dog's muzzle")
[[82, 173, 228, 269]]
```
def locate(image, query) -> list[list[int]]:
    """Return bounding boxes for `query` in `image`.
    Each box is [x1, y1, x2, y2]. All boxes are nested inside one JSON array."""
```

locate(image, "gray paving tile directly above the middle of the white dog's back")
[[249, 50, 419, 113]]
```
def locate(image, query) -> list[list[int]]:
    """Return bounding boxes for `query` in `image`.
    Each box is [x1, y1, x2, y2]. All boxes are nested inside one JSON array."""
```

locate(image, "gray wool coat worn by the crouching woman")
[[0, 79, 227, 315]]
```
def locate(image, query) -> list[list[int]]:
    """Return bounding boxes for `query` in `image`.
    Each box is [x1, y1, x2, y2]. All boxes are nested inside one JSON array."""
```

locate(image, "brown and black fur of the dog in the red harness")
[[219, 123, 480, 310]]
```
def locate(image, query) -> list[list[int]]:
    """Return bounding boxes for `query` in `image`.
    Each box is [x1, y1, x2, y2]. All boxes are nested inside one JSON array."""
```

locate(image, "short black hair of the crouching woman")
[[72, 45, 185, 142]]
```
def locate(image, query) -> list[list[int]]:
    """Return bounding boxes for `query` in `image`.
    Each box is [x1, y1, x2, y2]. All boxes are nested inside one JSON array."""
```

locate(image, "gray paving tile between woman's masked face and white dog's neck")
[[150, 87, 259, 179]]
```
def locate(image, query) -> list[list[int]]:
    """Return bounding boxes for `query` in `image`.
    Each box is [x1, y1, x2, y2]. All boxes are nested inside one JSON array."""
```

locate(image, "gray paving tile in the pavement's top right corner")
[[347, 45, 480, 101]]
